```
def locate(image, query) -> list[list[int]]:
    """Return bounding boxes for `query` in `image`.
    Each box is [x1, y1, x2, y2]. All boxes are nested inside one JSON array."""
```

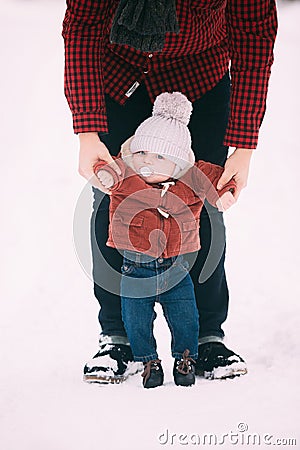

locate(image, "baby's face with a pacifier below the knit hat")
[[132, 150, 176, 183]]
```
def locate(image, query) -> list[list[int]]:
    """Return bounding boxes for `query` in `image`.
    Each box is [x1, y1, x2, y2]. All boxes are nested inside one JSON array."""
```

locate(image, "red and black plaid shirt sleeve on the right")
[[224, 0, 277, 148]]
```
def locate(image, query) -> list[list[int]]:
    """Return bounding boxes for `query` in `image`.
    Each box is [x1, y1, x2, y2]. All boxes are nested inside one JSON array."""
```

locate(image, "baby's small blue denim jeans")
[[121, 251, 199, 362]]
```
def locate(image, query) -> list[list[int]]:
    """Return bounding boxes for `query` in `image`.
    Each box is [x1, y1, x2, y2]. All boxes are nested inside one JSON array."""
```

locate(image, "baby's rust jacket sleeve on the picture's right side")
[[191, 161, 236, 207]]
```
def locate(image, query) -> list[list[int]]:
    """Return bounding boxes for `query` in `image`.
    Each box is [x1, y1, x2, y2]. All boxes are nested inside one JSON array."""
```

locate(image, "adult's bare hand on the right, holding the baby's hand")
[[217, 148, 253, 200]]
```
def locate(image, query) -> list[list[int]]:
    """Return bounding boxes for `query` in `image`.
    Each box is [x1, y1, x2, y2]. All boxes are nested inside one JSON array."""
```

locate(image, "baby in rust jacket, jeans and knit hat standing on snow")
[[94, 92, 236, 388]]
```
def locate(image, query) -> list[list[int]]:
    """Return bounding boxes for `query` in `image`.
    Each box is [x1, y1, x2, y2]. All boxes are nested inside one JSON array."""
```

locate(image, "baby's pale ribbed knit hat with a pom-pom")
[[130, 92, 195, 176]]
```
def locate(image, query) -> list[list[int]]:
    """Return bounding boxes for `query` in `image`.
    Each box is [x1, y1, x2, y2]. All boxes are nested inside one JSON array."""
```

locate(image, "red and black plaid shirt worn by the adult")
[[63, 0, 277, 148]]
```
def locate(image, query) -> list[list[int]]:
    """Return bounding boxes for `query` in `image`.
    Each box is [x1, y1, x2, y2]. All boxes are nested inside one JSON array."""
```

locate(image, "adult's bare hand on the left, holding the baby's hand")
[[78, 133, 120, 192]]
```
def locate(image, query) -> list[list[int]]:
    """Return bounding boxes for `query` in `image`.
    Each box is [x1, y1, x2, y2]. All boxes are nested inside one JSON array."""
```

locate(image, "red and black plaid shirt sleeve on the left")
[[62, 0, 110, 133]]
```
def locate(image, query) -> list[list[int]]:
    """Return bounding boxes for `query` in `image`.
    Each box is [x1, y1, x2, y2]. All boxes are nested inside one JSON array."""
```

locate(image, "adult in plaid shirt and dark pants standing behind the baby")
[[63, 0, 277, 382]]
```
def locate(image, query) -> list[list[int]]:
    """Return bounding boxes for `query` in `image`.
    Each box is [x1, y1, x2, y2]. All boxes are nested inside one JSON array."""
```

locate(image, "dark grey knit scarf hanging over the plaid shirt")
[[110, 0, 179, 52]]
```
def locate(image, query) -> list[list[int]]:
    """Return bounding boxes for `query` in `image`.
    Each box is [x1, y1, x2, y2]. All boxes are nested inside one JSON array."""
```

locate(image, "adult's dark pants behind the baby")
[[91, 74, 230, 338]]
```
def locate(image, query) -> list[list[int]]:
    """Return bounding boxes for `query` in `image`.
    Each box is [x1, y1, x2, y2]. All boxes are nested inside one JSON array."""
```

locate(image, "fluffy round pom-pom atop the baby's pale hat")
[[152, 92, 193, 125]]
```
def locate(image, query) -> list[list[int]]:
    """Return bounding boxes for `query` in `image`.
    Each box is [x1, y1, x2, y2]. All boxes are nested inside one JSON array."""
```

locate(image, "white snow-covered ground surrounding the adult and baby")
[[0, 0, 300, 450]]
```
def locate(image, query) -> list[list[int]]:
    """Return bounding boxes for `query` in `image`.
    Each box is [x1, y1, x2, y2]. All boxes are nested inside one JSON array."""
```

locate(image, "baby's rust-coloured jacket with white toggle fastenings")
[[94, 158, 236, 258]]
